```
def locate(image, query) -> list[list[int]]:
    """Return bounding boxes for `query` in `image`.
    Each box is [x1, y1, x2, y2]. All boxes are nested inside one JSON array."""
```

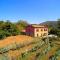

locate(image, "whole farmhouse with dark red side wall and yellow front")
[[26, 24, 48, 37]]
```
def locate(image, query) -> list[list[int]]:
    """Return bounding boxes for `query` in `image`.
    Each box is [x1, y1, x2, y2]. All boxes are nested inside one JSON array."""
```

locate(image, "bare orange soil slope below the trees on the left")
[[0, 35, 32, 47]]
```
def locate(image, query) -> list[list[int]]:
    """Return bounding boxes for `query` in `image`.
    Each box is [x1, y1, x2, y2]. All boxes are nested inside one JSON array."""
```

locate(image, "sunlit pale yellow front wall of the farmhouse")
[[34, 28, 48, 37]]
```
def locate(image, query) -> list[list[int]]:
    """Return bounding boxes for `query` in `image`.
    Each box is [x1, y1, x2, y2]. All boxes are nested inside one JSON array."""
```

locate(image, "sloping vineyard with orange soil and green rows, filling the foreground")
[[0, 35, 60, 60]]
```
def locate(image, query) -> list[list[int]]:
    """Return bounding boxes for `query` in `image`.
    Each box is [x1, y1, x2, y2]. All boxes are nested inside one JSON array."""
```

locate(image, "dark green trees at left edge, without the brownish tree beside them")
[[0, 21, 20, 39]]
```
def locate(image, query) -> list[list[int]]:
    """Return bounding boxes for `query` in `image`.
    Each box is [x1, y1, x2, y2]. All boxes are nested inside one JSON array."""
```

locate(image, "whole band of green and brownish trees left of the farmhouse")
[[0, 20, 28, 39]]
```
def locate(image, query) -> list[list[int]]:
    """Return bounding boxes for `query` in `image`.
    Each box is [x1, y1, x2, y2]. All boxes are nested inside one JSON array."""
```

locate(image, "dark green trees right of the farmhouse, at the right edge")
[[48, 19, 60, 36]]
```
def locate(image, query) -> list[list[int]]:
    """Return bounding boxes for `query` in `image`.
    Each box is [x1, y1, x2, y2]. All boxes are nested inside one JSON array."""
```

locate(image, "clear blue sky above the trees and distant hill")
[[0, 0, 60, 23]]
